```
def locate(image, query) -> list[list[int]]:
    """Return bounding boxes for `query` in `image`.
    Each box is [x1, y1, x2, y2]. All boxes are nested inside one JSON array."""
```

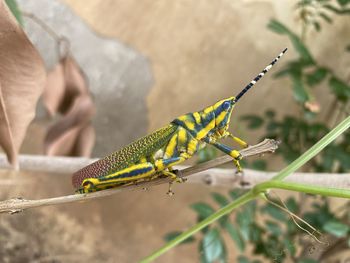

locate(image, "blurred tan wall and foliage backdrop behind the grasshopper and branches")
[[0, 0, 350, 262]]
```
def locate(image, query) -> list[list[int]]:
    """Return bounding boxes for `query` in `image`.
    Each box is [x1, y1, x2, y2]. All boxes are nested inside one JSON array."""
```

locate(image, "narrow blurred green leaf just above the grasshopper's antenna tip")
[[267, 19, 314, 64]]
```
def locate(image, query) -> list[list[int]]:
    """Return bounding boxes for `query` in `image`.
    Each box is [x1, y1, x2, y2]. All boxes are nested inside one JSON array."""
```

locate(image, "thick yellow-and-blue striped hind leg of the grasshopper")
[[77, 162, 156, 193]]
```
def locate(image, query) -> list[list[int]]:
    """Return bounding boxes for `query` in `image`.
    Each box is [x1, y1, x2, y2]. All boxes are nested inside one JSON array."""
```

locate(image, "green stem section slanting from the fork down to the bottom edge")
[[140, 191, 256, 263]]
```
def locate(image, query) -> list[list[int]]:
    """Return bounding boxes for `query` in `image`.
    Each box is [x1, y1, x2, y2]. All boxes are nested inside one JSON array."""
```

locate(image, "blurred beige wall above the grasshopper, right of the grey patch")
[[65, 0, 349, 140]]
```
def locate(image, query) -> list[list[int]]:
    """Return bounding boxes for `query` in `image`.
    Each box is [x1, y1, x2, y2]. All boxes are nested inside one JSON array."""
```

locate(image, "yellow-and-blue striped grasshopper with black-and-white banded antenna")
[[72, 49, 287, 194]]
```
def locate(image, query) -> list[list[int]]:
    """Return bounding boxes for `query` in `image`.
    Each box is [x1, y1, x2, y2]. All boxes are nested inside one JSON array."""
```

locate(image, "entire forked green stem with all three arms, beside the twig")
[[141, 116, 350, 263]]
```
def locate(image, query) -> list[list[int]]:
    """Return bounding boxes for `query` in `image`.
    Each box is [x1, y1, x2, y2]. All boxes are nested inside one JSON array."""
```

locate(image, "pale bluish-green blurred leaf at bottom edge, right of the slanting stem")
[[202, 228, 225, 262]]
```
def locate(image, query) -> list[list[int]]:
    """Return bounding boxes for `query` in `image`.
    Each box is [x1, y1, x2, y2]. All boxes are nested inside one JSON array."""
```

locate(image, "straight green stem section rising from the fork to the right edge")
[[272, 116, 350, 183]]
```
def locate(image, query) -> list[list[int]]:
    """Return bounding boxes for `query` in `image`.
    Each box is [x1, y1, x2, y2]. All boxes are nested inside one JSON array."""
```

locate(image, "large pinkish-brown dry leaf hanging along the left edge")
[[0, 1, 46, 166]]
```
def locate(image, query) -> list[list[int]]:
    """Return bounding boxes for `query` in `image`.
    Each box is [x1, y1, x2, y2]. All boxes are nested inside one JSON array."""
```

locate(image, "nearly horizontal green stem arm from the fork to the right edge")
[[253, 180, 350, 199]]
